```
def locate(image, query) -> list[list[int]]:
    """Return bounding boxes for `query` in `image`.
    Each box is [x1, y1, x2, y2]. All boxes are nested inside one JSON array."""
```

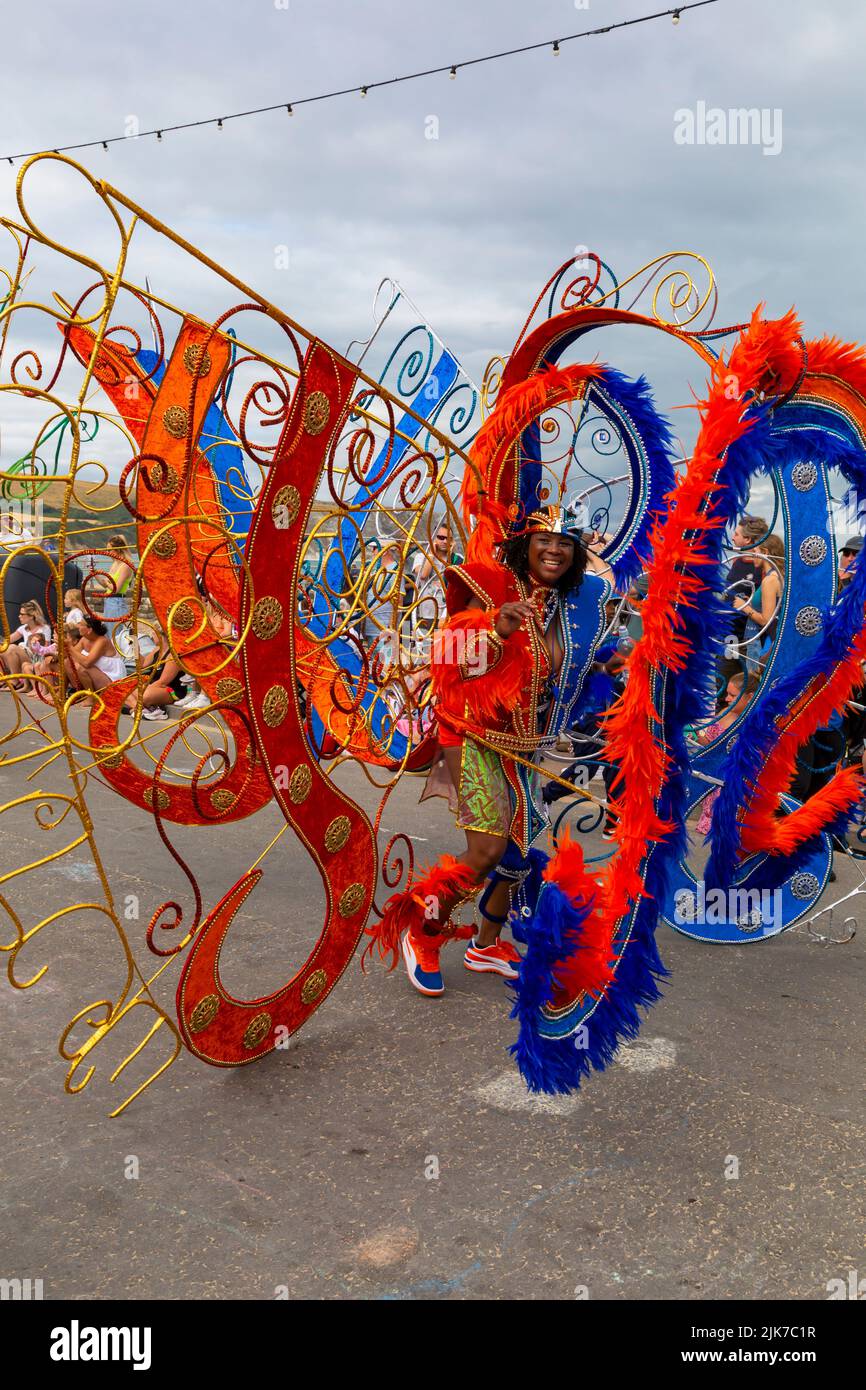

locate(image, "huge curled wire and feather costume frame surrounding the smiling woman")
[[0, 154, 866, 1115]]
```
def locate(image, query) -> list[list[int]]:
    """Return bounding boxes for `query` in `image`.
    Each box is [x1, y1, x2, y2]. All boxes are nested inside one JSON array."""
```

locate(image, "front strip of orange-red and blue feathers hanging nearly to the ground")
[[514, 309, 802, 1090]]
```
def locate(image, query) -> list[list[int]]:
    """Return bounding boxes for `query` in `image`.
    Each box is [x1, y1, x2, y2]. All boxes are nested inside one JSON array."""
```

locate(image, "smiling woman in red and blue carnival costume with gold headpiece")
[[367, 507, 610, 995]]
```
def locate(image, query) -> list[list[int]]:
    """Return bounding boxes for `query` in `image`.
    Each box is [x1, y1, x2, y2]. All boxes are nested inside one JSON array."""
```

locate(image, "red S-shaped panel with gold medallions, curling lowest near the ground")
[[178, 343, 377, 1066]]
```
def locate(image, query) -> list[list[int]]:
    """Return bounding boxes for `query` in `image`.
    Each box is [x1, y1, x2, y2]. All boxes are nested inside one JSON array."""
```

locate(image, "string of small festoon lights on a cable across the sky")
[[0, 0, 719, 164]]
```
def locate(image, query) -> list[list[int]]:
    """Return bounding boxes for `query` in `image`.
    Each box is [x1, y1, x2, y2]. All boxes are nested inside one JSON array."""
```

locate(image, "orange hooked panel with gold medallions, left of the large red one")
[[70, 320, 271, 826]]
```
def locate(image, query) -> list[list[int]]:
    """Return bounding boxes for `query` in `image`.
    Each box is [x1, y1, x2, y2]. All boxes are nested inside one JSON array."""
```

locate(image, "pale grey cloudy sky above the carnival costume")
[[0, 0, 866, 486]]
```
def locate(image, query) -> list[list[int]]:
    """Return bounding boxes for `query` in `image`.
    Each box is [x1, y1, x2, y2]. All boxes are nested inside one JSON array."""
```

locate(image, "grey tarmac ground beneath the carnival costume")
[[0, 694, 866, 1300]]
